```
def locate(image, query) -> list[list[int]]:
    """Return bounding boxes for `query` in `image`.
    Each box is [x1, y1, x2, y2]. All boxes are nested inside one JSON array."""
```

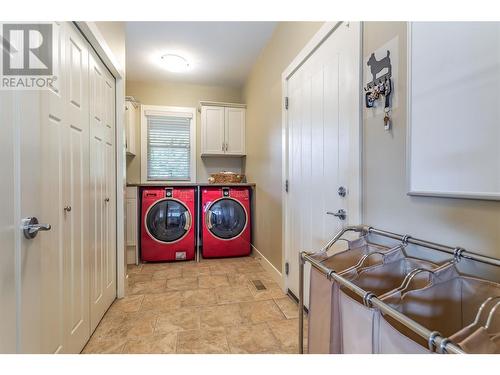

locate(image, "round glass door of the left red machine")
[[146, 198, 191, 243]]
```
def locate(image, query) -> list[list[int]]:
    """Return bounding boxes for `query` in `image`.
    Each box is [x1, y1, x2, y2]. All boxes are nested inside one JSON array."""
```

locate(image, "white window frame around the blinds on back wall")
[[141, 105, 197, 184]]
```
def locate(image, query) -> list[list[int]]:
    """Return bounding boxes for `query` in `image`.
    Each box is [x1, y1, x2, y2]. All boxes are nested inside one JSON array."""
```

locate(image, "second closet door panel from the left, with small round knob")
[[63, 27, 90, 353]]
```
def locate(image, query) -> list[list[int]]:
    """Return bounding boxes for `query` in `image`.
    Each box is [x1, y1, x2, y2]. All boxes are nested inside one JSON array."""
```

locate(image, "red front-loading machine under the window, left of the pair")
[[141, 187, 196, 262]]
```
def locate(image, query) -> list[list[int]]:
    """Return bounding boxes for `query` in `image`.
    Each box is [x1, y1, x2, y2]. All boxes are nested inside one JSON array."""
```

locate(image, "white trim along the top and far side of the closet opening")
[[74, 21, 127, 298]]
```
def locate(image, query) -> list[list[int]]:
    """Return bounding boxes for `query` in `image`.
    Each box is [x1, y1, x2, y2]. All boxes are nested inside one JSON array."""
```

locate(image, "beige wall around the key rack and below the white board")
[[363, 22, 500, 280]]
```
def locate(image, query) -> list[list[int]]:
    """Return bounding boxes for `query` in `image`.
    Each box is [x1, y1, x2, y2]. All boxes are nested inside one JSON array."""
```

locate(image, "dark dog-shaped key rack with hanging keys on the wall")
[[365, 50, 393, 130]]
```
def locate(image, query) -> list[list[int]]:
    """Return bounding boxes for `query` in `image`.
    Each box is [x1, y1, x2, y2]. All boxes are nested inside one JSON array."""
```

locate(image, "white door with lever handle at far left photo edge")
[[0, 53, 49, 353]]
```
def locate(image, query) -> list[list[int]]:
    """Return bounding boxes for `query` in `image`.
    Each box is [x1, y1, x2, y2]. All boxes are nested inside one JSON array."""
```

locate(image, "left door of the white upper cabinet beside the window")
[[201, 106, 225, 155]]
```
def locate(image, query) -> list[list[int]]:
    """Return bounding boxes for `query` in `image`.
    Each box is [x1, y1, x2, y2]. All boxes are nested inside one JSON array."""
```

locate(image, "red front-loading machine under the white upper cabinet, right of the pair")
[[201, 187, 251, 258]]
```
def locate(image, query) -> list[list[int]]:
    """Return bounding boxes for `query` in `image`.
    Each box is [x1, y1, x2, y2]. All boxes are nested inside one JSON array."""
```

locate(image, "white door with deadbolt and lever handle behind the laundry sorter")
[[284, 23, 360, 306]]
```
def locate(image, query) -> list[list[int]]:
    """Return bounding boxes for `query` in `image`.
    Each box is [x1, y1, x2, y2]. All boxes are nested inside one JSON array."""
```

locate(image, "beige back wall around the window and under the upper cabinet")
[[127, 81, 242, 183]]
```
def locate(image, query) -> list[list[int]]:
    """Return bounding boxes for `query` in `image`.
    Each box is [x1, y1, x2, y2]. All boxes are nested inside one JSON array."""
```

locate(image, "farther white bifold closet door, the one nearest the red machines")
[[90, 48, 116, 330]]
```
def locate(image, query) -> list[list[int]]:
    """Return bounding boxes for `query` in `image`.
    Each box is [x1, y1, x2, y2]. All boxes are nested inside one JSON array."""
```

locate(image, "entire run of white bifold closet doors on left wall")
[[39, 23, 116, 353]]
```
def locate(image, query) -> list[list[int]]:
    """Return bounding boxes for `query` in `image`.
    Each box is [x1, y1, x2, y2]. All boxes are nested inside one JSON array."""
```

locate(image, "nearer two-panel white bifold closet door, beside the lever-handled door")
[[40, 24, 90, 353]]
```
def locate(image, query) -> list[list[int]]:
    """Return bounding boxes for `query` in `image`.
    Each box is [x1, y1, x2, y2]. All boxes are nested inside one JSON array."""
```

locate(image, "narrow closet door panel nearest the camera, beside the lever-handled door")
[[39, 23, 67, 353]]
